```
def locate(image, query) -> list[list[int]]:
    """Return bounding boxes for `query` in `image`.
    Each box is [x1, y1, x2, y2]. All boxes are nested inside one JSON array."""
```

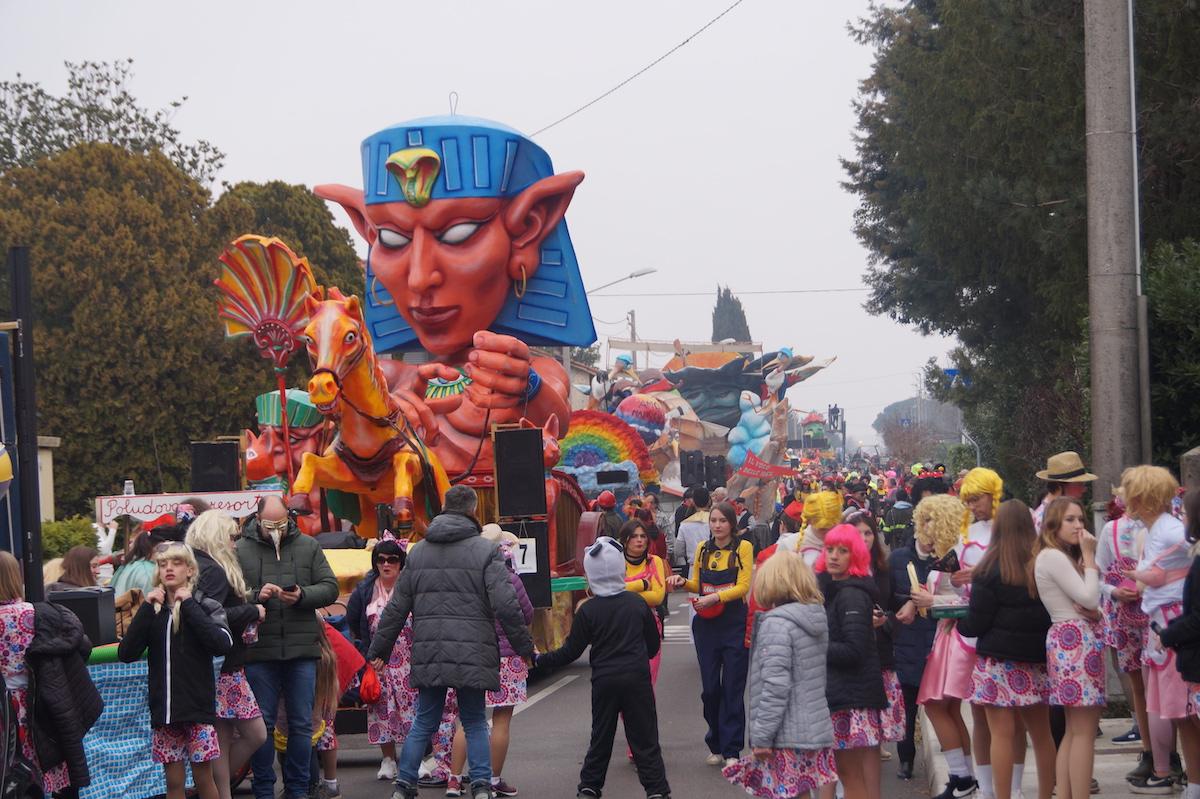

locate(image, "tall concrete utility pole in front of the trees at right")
[[1084, 0, 1148, 503]]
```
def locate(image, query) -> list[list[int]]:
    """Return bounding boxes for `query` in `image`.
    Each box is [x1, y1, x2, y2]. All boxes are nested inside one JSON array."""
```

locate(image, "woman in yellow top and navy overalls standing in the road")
[[667, 503, 754, 765]]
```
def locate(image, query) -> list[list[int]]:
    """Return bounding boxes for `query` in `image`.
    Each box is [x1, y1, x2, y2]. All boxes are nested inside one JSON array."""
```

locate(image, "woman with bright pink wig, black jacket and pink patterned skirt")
[[816, 524, 888, 799]]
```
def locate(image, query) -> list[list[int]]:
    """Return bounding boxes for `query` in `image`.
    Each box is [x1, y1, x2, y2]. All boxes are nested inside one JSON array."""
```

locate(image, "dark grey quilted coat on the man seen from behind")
[[367, 512, 533, 691]]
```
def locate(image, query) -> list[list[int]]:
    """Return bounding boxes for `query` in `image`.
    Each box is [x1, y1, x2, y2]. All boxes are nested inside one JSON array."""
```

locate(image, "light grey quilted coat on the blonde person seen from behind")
[[749, 602, 833, 749]]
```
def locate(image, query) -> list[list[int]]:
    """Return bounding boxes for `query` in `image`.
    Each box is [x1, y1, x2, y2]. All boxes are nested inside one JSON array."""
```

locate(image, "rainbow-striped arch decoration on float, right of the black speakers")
[[558, 410, 659, 494]]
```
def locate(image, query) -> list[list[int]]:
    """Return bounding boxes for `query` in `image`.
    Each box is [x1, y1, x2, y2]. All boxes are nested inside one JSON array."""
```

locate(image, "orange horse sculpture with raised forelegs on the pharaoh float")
[[288, 288, 450, 539]]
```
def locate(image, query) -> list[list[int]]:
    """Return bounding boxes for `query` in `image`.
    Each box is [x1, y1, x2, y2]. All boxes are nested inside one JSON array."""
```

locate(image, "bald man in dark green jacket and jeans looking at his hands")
[[238, 497, 337, 799]]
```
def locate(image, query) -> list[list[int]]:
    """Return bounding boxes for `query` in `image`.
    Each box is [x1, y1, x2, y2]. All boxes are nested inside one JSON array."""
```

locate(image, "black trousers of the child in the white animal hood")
[[578, 678, 671, 795]]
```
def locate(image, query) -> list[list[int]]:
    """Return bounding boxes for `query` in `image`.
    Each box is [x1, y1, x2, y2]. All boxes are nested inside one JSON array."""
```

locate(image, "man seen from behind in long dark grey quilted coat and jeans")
[[367, 486, 533, 799]]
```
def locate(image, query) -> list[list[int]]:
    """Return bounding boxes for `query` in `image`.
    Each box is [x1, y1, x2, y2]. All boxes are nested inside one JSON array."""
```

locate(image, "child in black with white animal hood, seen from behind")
[[538, 536, 671, 799]]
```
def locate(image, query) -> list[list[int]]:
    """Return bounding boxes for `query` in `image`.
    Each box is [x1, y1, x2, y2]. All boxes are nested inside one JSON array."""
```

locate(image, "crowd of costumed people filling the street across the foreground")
[[7, 452, 1200, 799]]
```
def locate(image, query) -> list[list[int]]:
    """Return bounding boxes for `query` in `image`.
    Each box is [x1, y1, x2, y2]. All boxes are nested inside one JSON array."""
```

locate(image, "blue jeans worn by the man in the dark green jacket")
[[246, 657, 317, 799]]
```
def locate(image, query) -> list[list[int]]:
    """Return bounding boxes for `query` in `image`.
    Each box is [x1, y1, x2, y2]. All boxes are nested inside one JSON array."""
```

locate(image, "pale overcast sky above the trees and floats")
[[0, 0, 952, 446]]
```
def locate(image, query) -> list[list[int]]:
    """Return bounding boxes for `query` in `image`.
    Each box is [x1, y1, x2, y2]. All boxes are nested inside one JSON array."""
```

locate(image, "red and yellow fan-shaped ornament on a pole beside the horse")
[[212, 234, 317, 485]]
